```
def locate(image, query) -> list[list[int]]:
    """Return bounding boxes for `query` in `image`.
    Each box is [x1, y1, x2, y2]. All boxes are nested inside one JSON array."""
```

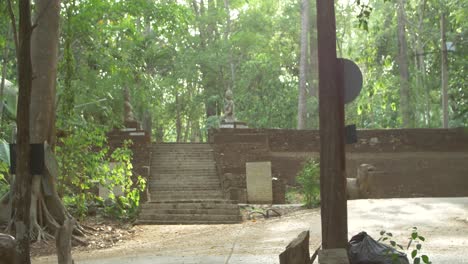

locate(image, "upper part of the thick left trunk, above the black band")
[[30, 0, 60, 144]]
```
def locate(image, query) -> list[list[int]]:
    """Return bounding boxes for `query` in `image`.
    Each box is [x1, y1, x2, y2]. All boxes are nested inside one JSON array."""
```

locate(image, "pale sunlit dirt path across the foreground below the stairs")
[[33, 198, 468, 264]]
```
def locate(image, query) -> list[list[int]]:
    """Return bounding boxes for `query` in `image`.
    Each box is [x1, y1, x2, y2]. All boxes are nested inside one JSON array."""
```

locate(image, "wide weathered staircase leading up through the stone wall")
[[137, 143, 241, 224]]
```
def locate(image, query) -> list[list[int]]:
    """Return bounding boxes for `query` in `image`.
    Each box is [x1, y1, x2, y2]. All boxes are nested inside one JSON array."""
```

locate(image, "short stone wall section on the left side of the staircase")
[[107, 128, 151, 201]]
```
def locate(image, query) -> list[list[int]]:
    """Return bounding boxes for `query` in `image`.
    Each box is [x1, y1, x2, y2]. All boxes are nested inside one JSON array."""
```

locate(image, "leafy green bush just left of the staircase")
[[56, 128, 145, 219]]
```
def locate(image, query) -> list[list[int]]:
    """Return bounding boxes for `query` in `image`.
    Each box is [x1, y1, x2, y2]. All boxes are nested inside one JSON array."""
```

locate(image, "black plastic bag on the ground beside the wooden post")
[[349, 232, 409, 264]]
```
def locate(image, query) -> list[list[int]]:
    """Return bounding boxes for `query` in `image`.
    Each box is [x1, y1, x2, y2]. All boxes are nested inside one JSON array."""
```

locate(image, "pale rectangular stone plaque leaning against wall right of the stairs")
[[245, 161, 273, 204]]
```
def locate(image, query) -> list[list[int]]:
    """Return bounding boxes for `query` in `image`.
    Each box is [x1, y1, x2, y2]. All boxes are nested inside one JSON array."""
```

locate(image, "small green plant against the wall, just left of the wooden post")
[[296, 159, 320, 208]]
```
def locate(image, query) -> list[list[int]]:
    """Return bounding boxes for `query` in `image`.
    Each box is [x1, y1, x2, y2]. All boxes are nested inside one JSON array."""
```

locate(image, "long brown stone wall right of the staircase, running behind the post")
[[209, 128, 468, 203]]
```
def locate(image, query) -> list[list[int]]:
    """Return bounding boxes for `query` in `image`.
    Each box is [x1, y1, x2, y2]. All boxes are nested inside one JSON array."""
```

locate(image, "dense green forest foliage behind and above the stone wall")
[[0, 0, 468, 141]]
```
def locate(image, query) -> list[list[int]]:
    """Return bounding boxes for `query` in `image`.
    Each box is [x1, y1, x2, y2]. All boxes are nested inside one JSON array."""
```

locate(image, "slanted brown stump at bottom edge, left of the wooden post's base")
[[279, 231, 310, 264]]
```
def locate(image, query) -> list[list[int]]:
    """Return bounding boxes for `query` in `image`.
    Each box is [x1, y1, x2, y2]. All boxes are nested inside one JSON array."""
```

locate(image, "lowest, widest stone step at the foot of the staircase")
[[138, 213, 242, 222]]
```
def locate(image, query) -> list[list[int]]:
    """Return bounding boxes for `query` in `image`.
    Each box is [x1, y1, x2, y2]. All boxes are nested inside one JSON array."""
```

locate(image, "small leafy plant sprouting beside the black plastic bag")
[[377, 227, 432, 264]]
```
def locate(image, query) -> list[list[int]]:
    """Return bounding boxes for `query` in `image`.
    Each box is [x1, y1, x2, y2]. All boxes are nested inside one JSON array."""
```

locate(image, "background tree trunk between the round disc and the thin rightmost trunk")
[[398, 0, 413, 128]]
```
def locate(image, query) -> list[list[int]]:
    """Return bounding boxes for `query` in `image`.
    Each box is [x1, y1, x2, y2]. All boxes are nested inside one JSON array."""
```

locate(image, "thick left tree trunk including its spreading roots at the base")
[[11, 0, 87, 251]]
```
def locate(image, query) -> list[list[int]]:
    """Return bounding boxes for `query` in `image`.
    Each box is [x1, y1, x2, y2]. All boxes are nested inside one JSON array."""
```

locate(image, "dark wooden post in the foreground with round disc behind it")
[[317, 0, 348, 249]]
